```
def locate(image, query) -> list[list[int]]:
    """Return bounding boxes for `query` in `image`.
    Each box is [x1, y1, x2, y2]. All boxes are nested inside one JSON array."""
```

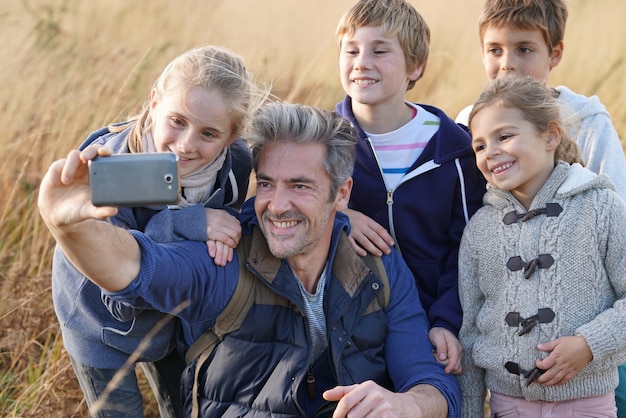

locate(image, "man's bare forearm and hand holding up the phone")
[[38, 146, 141, 291]]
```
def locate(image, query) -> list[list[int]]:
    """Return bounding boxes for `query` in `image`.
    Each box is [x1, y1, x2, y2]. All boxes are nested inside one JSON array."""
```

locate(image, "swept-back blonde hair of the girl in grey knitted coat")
[[468, 77, 584, 165]]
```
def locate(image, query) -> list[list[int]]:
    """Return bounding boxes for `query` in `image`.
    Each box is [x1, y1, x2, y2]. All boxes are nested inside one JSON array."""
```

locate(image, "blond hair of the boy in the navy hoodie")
[[336, 0, 430, 90]]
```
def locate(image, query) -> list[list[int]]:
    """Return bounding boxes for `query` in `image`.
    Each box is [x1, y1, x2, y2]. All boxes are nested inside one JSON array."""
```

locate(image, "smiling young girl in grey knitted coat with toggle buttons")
[[459, 77, 626, 417]]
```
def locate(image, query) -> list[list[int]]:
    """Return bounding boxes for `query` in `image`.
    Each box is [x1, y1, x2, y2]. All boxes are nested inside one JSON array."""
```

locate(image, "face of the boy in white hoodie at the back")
[[482, 26, 563, 84]]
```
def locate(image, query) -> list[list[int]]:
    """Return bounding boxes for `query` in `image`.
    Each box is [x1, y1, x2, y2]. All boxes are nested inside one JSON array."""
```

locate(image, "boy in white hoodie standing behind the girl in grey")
[[456, 0, 626, 202]]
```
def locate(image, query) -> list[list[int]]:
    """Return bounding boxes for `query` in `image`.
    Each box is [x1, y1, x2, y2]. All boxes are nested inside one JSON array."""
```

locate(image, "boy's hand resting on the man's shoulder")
[[343, 209, 394, 257]]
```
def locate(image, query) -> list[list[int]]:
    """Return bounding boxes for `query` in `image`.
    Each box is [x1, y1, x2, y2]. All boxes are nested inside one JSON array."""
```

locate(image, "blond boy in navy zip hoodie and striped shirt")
[[336, 0, 485, 373]]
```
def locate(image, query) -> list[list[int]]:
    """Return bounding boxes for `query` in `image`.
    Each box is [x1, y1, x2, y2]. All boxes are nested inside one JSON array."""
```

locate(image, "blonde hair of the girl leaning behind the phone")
[[109, 45, 268, 152]]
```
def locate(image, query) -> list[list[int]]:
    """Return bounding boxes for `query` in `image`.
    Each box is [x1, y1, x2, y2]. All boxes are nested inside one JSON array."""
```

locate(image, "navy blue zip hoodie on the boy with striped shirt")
[[336, 96, 486, 335]]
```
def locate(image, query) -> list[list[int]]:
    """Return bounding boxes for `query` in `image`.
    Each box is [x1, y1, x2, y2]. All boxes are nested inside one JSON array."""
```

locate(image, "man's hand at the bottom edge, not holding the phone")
[[324, 381, 448, 418]]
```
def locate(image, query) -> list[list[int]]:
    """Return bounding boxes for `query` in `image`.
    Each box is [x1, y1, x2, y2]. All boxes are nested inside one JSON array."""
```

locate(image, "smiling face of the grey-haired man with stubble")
[[254, 142, 352, 259]]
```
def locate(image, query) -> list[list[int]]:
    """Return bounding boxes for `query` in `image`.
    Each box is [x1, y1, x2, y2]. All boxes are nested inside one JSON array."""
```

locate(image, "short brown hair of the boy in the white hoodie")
[[478, 0, 567, 52]]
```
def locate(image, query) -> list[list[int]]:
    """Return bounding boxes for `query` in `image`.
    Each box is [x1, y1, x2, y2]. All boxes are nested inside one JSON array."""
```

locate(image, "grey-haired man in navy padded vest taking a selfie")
[[39, 103, 460, 417]]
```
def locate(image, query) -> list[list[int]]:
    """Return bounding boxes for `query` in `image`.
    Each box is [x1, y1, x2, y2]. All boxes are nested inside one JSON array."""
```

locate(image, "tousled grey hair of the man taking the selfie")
[[246, 102, 356, 200]]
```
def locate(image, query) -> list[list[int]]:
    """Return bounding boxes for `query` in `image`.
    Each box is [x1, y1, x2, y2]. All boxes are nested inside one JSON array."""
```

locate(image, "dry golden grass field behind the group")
[[0, 0, 626, 417]]
